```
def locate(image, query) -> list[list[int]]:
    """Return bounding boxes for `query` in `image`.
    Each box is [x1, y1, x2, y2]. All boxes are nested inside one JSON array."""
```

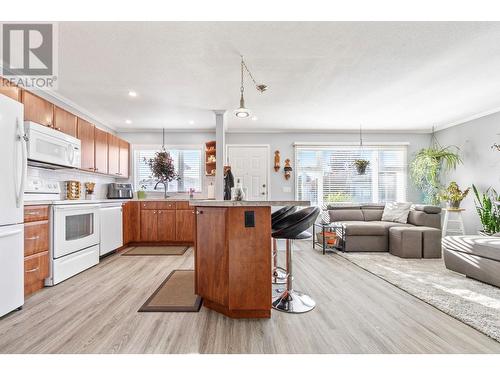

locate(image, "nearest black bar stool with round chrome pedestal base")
[[272, 207, 320, 313]]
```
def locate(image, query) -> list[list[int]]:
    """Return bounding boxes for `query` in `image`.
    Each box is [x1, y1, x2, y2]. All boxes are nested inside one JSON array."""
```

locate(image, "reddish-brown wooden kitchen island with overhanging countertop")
[[189, 200, 310, 318]]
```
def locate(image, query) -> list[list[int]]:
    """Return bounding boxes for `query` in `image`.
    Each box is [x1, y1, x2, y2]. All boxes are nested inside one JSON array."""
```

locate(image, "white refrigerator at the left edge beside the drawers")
[[0, 94, 27, 316]]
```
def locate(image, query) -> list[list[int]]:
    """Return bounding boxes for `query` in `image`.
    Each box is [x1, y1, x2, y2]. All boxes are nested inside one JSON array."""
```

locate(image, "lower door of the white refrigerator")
[[0, 224, 24, 316]]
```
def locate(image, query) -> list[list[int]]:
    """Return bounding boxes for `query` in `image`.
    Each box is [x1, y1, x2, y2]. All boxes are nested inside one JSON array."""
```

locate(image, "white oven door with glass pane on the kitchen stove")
[[52, 204, 100, 259]]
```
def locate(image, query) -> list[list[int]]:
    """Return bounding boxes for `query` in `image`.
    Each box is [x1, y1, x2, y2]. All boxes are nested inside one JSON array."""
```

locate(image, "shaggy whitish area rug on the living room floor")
[[337, 252, 500, 341]]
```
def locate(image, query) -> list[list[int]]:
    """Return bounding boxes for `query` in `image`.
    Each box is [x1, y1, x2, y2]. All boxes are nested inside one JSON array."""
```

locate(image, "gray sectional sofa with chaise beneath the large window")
[[327, 204, 441, 258]]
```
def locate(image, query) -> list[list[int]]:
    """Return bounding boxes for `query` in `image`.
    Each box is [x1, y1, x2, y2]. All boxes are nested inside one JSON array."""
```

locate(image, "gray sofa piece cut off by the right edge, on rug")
[[443, 235, 500, 287]]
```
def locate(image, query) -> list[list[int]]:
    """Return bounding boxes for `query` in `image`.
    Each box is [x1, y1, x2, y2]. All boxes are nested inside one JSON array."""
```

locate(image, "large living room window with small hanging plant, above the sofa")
[[295, 145, 407, 206]]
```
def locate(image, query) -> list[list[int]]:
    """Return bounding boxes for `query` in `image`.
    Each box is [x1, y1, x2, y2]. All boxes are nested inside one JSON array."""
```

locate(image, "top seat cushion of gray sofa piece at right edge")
[[443, 235, 500, 261]]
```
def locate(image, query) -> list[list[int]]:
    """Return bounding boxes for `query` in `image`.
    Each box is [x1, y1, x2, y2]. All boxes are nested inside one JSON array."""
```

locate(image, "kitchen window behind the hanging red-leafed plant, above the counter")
[[134, 146, 202, 193]]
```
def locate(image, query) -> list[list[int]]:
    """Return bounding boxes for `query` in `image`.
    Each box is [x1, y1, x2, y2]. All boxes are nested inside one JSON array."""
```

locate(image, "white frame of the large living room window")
[[293, 142, 410, 207]]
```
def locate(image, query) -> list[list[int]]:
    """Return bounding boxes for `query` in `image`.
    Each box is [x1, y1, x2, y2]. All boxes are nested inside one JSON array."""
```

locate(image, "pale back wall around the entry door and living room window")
[[226, 132, 430, 202]]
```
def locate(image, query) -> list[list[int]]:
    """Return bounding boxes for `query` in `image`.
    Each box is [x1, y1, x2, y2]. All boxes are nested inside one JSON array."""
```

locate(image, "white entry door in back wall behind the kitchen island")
[[227, 145, 270, 201]]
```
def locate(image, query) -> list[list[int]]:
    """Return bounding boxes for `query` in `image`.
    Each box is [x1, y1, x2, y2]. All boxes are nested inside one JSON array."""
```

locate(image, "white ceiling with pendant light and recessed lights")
[[57, 22, 500, 131]]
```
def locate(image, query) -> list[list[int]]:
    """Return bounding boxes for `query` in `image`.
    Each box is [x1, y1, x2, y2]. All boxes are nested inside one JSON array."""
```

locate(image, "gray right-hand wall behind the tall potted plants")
[[436, 113, 500, 234]]
